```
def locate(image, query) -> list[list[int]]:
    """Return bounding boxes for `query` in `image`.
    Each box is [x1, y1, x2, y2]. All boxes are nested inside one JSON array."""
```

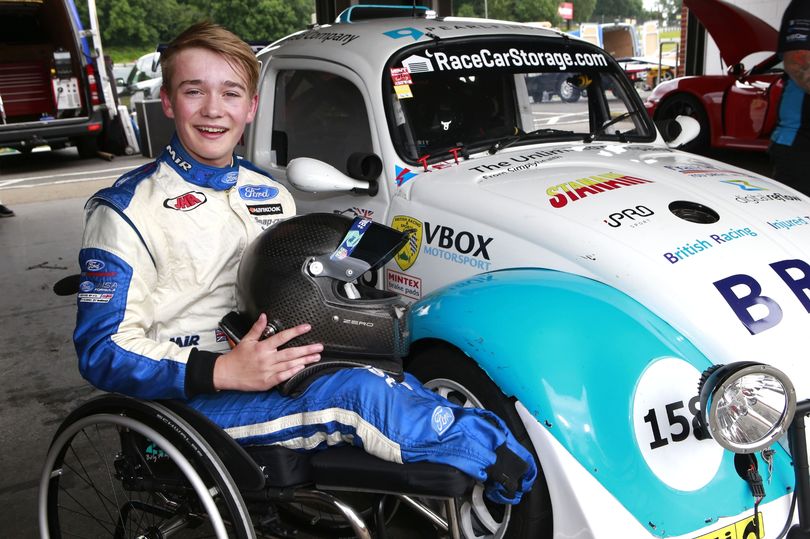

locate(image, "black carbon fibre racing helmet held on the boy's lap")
[[237, 213, 408, 392]]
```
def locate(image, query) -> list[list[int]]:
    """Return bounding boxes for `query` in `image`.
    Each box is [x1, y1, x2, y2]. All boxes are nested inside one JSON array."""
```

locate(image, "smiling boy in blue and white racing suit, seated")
[[74, 23, 536, 503]]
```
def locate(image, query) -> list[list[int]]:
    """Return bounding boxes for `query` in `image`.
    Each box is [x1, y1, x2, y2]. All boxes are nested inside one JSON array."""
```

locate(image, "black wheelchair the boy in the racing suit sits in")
[[38, 394, 502, 539]]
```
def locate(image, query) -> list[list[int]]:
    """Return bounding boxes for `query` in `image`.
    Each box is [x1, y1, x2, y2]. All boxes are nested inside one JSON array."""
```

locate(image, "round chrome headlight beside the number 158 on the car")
[[698, 361, 796, 453]]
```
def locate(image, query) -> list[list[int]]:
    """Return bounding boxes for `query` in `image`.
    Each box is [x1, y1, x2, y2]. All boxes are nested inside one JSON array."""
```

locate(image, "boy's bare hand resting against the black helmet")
[[214, 313, 323, 391]]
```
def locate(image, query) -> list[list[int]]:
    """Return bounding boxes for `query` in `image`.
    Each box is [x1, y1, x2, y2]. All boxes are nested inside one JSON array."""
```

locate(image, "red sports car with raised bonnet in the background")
[[645, 0, 784, 152]]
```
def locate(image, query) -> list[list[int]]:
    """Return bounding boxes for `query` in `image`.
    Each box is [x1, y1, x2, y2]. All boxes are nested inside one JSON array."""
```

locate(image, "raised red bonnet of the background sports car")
[[684, 0, 779, 65]]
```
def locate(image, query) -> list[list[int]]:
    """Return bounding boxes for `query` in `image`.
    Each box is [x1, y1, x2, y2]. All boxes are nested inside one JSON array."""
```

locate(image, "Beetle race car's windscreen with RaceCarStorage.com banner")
[[383, 36, 655, 163]]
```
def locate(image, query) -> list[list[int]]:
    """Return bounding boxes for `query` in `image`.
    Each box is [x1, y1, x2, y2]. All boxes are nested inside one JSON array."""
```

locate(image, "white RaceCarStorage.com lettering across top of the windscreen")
[[402, 47, 608, 73]]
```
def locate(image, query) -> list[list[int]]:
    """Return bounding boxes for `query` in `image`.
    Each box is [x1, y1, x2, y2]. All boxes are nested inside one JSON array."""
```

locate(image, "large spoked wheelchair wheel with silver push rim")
[[39, 397, 254, 539]]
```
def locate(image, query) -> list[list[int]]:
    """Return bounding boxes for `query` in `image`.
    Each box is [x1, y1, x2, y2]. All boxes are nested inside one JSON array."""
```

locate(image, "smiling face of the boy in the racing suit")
[[160, 48, 258, 167]]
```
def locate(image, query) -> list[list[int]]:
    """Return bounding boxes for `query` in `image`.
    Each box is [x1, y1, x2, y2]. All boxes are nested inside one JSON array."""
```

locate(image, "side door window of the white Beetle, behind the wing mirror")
[[271, 70, 373, 173]]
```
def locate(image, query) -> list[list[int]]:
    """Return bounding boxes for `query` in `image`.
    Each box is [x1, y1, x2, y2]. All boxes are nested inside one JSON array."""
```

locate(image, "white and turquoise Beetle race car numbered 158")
[[245, 6, 810, 539]]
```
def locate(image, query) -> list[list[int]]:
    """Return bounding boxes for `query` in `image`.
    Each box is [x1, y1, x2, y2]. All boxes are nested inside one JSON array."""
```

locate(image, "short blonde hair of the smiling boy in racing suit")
[[160, 21, 259, 97]]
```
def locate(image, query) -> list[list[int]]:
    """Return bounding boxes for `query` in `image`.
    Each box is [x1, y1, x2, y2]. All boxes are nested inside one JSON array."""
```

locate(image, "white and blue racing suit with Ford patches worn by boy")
[[74, 137, 536, 503]]
